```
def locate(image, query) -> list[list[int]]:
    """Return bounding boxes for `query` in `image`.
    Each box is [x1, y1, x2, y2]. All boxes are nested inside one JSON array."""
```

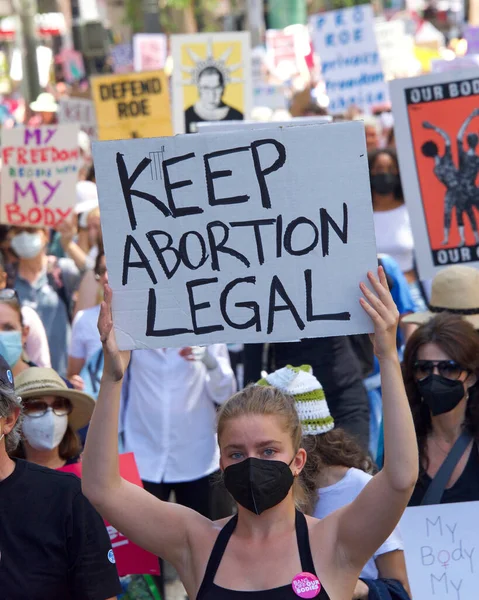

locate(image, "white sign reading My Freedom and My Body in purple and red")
[[0, 125, 79, 227]]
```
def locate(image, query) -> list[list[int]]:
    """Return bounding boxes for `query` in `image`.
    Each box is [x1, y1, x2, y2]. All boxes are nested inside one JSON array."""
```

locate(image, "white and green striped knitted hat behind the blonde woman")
[[257, 365, 334, 435]]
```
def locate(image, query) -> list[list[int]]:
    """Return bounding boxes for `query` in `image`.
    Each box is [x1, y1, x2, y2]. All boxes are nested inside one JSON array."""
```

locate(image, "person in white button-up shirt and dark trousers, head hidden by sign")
[[122, 344, 236, 518]]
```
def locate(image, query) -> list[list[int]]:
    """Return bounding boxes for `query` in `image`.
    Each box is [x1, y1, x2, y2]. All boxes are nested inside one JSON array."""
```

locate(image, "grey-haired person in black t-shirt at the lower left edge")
[[0, 356, 121, 600]]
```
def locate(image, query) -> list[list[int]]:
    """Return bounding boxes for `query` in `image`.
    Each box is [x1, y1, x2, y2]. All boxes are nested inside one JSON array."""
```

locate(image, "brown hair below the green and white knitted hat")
[[301, 427, 374, 515]]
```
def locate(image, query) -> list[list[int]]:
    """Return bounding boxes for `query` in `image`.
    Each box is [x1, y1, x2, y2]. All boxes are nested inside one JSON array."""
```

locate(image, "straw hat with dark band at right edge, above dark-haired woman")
[[401, 265, 479, 329]]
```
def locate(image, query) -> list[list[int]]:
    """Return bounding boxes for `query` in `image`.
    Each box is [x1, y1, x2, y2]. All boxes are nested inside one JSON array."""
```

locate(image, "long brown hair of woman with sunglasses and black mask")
[[402, 313, 479, 470]]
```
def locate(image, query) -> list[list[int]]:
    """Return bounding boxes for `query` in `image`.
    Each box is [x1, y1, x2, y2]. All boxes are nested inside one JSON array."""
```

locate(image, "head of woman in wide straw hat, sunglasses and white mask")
[[11, 367, 95, 469]]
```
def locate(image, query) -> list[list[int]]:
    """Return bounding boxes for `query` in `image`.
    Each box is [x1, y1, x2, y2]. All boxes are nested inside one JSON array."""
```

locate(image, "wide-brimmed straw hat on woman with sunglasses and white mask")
[[15, 367, 95, 431]]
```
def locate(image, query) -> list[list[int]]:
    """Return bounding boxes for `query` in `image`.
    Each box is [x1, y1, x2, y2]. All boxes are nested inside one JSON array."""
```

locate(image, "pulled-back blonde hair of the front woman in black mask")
[[218, 385, 307, 509]]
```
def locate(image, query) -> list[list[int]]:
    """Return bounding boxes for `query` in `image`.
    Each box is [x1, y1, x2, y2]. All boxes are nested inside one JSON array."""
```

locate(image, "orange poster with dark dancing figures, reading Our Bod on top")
[[391, 70, 479, 279]]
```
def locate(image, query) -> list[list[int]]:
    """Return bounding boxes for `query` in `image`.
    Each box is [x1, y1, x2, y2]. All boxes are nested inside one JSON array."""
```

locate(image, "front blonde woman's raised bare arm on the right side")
[[335, 267, 419, 569]]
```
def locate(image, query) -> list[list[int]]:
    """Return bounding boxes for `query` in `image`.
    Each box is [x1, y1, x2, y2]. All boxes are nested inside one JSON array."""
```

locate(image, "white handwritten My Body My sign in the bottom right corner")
[[399, 502, 479, 600]]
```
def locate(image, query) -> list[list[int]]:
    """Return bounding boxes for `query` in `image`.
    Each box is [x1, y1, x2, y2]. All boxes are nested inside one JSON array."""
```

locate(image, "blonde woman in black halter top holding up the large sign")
[[82, 269, 418, 600]]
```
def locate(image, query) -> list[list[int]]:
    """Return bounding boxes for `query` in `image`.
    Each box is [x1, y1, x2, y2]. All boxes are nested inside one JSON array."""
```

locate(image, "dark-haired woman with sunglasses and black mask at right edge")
[[403, 313, 479, 506]]
